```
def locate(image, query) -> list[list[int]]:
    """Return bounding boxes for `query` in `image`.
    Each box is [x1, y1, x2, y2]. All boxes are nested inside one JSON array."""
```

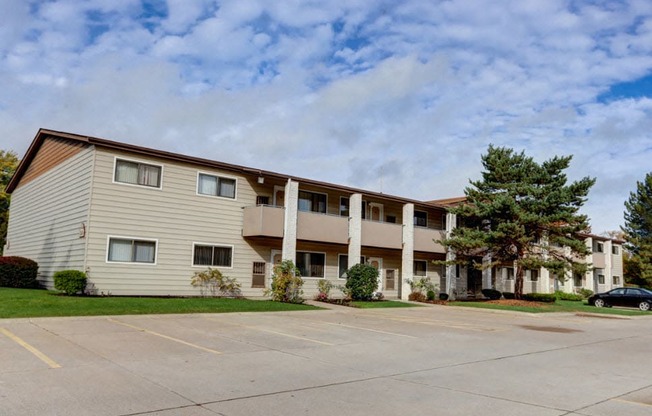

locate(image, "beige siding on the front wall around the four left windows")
[[88, 149, 271, 296]]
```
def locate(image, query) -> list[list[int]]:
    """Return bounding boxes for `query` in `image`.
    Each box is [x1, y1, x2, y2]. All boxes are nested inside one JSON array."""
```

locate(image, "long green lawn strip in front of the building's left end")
[[0, 287, 320, 318]]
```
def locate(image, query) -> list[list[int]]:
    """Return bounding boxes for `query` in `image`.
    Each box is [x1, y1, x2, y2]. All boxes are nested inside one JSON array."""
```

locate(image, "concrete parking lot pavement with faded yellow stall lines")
[[0, 306, 652, 416]]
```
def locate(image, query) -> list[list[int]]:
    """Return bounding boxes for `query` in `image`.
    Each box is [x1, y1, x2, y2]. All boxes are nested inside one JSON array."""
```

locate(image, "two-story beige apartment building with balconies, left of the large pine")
[[5, 129, 454, 298]]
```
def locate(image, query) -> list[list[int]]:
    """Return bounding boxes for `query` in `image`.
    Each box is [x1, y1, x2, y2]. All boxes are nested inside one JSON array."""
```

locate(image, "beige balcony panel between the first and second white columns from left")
[[297, 211, 349, 244]]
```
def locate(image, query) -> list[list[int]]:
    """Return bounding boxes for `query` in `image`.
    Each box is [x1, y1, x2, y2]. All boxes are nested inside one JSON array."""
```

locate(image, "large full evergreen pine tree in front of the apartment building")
[[443, 145, 595, 298]]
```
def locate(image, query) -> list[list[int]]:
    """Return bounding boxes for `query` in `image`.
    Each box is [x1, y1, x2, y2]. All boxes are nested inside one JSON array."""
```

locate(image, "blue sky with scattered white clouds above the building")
[[0, 0, 652, 233]]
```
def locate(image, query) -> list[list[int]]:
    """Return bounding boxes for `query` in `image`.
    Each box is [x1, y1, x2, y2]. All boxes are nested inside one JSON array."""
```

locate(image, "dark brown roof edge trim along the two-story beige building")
[[6, 128, 444, 208]]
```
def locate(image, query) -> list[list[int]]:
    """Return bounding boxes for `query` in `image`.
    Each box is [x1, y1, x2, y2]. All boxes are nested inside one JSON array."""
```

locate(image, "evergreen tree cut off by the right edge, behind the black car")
[[622, 173, 652, 286]]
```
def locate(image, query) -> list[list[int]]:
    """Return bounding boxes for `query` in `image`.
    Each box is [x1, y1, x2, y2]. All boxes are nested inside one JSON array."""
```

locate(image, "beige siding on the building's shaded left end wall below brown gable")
[[5, 147, 93, 287]]
